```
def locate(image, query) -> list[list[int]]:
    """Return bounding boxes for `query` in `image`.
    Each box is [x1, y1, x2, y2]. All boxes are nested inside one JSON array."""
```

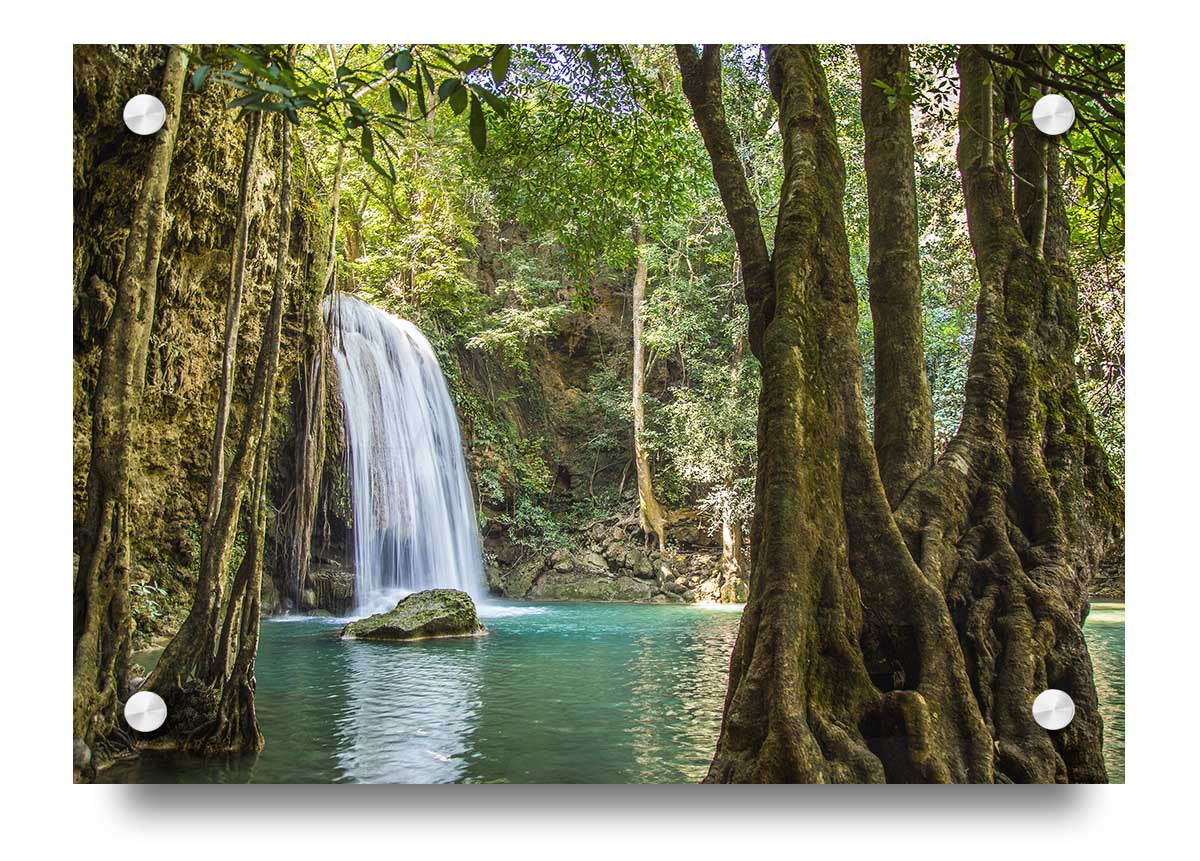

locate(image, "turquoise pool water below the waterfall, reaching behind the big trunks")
[[112, 603, 1124, 783]]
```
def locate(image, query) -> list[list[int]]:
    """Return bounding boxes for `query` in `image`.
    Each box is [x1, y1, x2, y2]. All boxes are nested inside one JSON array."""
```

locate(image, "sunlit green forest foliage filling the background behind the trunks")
[[267, 46, 1123, 549]]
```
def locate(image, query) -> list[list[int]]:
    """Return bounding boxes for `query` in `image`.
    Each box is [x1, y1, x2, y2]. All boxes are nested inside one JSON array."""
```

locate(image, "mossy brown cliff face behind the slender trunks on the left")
[[72, 44, 328, 646]]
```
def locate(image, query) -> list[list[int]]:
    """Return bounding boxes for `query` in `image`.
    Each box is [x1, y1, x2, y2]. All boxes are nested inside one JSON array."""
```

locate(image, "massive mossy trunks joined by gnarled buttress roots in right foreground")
[[677, 46, 1121, 782]]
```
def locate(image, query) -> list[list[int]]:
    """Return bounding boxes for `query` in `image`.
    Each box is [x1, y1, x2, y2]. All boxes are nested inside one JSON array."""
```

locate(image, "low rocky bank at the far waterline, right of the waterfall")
[[486, 516, 746, 603]]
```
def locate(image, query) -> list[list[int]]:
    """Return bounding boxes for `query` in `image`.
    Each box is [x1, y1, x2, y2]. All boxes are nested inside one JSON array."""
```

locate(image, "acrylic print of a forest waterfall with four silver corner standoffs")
[[73, 44, 1124, 783]]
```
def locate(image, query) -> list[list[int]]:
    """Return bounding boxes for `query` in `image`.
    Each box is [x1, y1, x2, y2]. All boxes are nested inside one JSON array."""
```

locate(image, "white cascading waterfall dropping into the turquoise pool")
[[325, 296, 484, 614]]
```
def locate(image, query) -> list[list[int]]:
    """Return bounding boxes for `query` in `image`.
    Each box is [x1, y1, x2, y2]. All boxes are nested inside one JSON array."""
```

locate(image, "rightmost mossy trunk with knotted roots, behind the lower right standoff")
[[898, 47, 1124, 782]]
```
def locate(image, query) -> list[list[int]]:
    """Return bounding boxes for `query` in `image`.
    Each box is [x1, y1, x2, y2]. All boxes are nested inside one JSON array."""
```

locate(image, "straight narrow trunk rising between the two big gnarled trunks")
[[858, 44, 934, 508]]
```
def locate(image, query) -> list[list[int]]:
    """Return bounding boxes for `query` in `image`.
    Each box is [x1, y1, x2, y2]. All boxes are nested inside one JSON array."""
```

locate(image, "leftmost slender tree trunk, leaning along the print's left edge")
[[72, 48, 187, 778]]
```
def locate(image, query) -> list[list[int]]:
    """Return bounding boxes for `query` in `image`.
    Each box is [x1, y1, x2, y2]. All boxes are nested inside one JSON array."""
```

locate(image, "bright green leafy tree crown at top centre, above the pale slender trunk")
[[485, 46, 708, 273]]
